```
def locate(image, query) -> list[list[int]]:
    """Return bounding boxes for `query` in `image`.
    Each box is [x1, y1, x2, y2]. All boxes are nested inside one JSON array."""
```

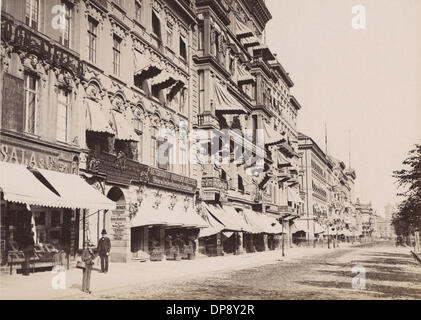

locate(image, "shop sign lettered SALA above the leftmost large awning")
[[0, 136, 78, 173]]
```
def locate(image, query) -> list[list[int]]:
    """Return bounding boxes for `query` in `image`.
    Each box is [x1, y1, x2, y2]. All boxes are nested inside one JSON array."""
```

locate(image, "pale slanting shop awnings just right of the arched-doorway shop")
[[199, 204, 283, 237]]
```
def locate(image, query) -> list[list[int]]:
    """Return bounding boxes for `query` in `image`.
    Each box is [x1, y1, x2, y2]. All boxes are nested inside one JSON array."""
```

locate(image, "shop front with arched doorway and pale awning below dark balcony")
[[86, 151, 203, 262]]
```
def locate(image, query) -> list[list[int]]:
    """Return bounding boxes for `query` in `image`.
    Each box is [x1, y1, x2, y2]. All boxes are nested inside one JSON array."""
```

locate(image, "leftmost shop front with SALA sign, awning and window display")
[[0, 135, 115, 272]]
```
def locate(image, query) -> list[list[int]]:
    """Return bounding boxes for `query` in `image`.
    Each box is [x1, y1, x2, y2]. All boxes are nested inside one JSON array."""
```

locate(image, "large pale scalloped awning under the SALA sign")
[[0, 162, 116, 211]]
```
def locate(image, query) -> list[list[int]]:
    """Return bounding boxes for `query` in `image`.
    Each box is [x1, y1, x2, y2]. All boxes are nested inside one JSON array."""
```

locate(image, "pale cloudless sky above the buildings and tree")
[[266, 0, 421, 214]]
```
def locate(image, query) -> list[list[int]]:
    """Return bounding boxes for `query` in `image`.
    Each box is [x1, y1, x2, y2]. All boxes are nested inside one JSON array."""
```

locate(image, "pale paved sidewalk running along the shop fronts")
[[0, 243, 351, 300]]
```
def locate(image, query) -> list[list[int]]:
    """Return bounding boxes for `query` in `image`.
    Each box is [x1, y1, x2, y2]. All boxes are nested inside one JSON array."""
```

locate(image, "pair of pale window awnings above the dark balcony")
[[85, 99, 139, 141]]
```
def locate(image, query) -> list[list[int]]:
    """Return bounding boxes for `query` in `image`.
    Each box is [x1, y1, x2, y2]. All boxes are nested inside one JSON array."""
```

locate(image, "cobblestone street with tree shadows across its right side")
[[65, 243, 421, 300]]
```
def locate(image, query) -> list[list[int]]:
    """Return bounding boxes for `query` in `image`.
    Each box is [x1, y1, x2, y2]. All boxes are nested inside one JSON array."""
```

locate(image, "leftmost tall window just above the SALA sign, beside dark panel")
[[24, 74, 38, 134]]
